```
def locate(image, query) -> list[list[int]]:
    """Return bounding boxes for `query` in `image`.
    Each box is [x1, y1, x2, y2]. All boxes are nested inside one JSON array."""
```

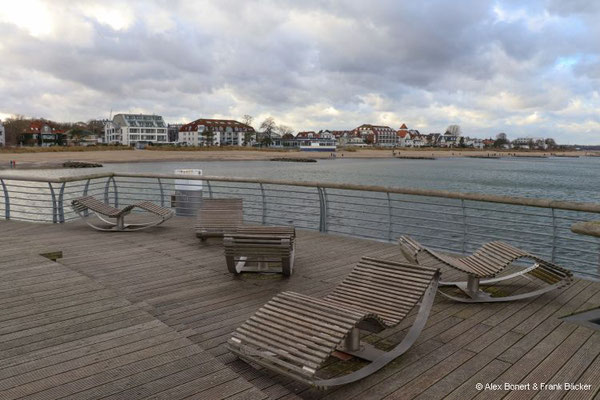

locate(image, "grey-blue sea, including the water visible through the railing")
[[0, 157, 600, 276]]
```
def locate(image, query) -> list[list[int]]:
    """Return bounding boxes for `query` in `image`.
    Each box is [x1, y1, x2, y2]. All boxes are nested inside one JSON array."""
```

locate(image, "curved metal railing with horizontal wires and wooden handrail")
[[0, 173, 600, 279]]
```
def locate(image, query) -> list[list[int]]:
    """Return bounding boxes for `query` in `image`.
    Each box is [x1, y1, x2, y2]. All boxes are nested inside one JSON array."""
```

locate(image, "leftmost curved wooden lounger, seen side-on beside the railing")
[[71, 196, 173, 231]]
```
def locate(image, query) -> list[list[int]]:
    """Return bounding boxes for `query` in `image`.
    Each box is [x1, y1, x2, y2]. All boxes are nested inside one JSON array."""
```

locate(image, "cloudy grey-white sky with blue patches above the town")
[[0, 0, 600, 144]]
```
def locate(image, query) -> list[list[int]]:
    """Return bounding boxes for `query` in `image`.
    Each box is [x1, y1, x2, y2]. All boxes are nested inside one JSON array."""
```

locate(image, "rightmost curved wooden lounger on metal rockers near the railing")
[[399, 236, 573, 303]]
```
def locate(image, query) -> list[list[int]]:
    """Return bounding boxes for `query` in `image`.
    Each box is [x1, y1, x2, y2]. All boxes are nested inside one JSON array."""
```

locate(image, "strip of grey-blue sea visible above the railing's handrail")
[[6, 157, 600, 202]]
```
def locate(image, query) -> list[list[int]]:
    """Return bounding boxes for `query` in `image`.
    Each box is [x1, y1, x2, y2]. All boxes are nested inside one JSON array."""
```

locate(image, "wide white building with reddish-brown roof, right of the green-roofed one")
[[178, 118, 254, 146]]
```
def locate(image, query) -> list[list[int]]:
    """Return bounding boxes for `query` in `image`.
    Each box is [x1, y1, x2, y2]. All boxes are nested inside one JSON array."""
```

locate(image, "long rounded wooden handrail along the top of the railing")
[[0, 172, 600, 213]]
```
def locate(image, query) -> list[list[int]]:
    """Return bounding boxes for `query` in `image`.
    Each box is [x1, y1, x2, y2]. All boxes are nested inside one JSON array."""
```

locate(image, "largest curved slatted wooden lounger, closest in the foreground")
[[227, 257, 439, 389]]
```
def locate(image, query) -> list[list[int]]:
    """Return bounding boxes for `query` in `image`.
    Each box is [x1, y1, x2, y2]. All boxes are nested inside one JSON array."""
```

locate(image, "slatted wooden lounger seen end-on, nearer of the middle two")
[[223, 226, 296, 276]]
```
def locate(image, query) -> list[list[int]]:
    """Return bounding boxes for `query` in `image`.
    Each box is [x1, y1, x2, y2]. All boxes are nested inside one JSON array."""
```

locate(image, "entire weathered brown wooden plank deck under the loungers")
[[0, 217, 600, 400]]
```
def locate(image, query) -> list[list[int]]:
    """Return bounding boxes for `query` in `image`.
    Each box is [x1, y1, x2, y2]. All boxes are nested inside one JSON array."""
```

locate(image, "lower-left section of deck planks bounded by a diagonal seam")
[[0, 234, 266, 399]]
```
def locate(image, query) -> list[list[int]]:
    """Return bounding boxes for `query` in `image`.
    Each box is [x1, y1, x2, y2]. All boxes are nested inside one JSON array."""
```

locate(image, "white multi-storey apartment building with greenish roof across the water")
[[104, 114, 168, 146]]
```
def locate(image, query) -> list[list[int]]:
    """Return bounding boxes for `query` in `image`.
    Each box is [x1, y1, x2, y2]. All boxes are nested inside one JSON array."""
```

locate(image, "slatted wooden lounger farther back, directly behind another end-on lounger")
[[196, 199, 244, 241]]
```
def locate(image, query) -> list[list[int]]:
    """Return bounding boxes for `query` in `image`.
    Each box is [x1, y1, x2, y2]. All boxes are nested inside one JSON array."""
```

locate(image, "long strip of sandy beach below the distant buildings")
[[0, 149, 599, 169]]
